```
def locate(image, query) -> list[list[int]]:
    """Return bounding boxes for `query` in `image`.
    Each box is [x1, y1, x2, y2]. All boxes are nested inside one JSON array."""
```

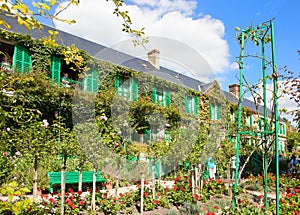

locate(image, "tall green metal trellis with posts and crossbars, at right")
[[233, 20, 280, 215]]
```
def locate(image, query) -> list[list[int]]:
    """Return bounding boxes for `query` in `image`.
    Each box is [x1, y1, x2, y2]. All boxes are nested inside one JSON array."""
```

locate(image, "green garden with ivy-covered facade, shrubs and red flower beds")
[[0, 26, 300, 215]]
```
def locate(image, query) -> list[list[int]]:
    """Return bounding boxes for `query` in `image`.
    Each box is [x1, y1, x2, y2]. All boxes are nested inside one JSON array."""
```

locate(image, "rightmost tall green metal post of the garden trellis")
[[270, 21, 280, 215]]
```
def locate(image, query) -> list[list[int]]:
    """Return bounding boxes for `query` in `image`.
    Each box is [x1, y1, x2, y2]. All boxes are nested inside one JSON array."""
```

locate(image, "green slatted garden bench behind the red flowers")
[[47, 171, 106, 193]]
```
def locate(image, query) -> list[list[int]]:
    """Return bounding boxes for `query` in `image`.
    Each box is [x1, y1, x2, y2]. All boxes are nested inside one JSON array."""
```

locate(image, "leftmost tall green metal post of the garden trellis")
[[233, 31, 245, 210]]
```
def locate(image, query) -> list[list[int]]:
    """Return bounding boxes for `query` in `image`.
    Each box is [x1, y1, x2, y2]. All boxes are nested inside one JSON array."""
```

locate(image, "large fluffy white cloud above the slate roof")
[[56, 0, 230, 78]]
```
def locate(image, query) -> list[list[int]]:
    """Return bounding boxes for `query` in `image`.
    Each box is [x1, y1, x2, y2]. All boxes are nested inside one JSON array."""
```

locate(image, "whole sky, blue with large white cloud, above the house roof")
[[41, 0, 300, 123]]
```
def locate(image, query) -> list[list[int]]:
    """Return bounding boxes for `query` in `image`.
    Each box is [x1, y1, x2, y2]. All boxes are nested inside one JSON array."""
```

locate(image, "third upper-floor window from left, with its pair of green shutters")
[[115, 75, 138, 101]]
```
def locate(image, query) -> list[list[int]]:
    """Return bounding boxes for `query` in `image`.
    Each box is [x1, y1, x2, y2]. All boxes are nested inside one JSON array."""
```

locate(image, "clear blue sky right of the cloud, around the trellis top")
[[196, 0, 300, 87]]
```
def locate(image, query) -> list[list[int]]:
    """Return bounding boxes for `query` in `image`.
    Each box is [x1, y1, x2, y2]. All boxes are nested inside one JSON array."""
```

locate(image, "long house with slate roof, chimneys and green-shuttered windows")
[[0, 17, 286, 155]]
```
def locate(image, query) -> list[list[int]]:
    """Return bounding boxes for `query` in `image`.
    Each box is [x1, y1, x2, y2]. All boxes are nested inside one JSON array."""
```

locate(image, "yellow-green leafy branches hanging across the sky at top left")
[[0, 0, 147, 45]]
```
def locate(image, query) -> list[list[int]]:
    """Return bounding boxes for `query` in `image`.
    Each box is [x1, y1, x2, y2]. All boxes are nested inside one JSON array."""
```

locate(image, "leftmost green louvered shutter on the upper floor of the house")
[[13, 45, 31, 73]]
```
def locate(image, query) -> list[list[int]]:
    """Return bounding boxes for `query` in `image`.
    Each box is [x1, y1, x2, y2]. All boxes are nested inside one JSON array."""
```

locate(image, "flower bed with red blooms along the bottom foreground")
[[0, 170, 300, 215]]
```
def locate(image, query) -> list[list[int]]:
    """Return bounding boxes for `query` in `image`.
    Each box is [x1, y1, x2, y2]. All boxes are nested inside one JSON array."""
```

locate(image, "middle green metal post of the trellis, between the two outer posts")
[[261, 38, 268, 210]]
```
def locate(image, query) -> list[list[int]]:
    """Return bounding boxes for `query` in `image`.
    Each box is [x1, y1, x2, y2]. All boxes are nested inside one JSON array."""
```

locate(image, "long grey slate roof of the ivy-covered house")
[[0, 15, 271, 114]]
